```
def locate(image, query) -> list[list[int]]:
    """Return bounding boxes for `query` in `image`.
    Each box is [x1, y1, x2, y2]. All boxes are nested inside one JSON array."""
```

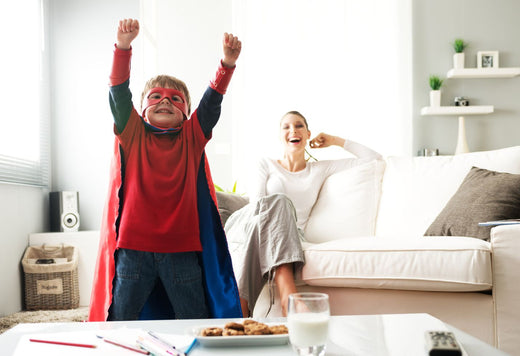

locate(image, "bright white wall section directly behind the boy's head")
[[139, 0, 235, 189]]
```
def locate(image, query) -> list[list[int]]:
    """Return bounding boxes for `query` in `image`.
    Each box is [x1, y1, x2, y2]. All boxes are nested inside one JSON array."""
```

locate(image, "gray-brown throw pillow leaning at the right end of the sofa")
[[424, 167, 520, 240]]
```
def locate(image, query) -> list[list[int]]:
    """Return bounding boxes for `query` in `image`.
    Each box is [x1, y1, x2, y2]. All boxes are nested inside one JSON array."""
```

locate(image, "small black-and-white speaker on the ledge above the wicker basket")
[[49, 191, 79, 232]]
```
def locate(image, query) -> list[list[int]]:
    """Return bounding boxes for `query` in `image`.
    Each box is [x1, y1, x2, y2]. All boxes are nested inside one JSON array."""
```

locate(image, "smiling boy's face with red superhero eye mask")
[[143, 88, 187, 129]]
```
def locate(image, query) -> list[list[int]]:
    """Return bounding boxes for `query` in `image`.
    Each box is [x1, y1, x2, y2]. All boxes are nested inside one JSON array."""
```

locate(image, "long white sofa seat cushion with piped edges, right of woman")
[[301, 236, 492, 292]]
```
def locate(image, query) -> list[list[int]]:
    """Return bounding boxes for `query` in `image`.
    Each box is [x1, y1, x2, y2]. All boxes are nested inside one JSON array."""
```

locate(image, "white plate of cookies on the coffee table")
[[193, 319, 289, 347]]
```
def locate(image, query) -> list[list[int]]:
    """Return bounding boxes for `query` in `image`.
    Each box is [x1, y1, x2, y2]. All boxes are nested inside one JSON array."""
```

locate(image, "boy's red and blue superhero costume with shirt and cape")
[[89, 48, 242, 321]]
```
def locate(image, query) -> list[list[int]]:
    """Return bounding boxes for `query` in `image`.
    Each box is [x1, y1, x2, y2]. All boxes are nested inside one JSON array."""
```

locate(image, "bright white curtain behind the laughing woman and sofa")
[[232, 0, 412, 193]]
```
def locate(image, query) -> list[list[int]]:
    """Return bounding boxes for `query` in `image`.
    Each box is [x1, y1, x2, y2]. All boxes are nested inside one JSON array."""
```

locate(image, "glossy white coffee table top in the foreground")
[[0, 314, 507, 356]]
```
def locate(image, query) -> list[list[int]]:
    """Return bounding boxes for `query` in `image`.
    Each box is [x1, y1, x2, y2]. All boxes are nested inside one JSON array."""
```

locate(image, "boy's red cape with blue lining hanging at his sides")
[[88, 138, 242, 321]]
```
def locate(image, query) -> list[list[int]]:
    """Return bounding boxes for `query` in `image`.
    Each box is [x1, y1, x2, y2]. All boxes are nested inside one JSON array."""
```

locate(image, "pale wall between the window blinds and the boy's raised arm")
[[50, 0, 140, 230]]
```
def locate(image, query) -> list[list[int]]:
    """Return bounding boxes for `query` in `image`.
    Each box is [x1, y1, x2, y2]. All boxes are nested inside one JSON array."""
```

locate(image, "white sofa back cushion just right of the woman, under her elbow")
[[305, 160, 385, 243]]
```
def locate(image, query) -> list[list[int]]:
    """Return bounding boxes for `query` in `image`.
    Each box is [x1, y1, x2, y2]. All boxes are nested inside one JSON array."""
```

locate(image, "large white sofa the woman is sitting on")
[[219, 146, 520, 354]]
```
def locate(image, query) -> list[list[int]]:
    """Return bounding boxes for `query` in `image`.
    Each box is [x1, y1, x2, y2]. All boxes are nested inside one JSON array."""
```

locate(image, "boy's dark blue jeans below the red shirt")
[[108, 249, 209, 320]]
